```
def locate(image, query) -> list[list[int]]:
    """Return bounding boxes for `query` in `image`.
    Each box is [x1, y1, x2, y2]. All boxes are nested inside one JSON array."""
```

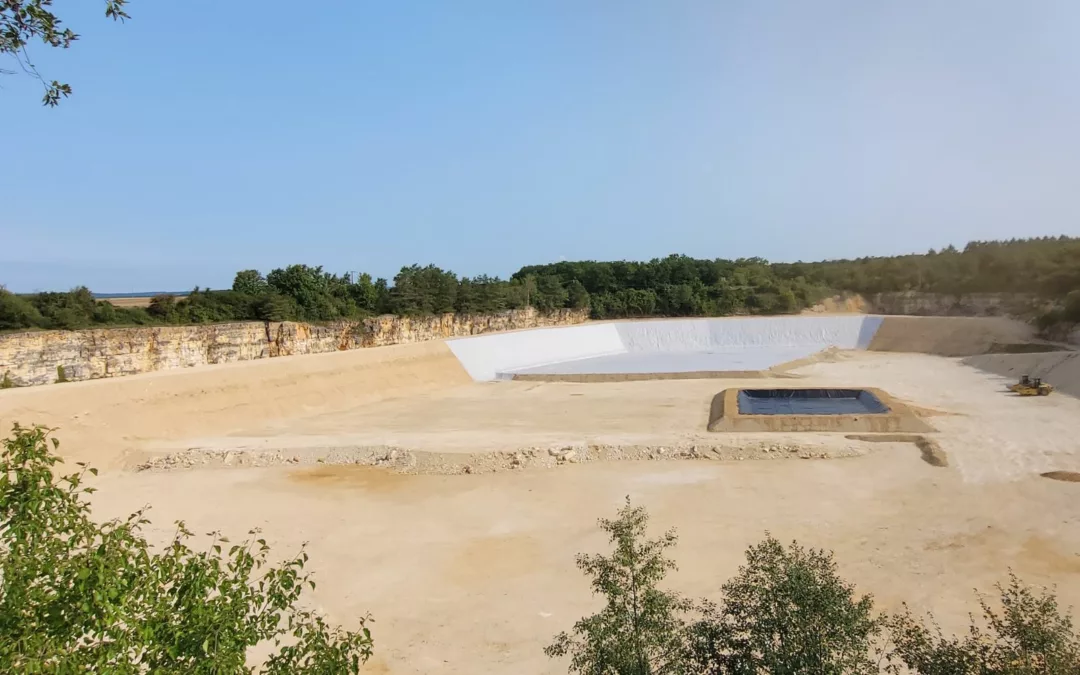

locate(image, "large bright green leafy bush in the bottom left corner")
[[0, 424, 372, 674]]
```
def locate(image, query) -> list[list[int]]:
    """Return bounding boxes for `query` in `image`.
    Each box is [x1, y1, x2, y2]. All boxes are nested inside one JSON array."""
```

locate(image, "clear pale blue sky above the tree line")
[[0, 0, 1080, 292]]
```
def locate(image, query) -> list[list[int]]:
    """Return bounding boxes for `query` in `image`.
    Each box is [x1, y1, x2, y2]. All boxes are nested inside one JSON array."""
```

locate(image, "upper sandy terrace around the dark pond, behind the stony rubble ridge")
[[116, 352, 1080, 482]]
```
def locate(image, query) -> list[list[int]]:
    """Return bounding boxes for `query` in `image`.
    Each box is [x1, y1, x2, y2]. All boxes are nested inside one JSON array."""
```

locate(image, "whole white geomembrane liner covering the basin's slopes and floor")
[[448, 315, 882, 381]]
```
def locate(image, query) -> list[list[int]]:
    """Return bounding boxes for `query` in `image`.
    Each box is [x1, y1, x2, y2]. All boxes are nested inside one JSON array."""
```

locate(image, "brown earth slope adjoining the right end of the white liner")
[[869, 316, 1035, 356]]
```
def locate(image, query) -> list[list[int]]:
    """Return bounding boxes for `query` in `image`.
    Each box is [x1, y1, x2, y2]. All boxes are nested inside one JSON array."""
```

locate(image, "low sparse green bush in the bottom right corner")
[[889, 573, 1080, 675]]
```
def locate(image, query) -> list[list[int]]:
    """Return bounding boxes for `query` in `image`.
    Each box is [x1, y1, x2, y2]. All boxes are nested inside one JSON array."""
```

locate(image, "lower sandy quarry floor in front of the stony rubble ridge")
[[86, 444, 1080, 674]]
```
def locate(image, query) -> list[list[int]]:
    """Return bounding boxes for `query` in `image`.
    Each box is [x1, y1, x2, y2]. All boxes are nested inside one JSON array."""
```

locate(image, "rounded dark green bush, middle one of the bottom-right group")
[[691, 535, 880, 675]]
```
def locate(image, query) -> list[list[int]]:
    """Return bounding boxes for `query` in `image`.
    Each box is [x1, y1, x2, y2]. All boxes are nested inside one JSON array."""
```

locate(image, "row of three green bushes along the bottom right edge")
[[546, 501, 1080, 675]]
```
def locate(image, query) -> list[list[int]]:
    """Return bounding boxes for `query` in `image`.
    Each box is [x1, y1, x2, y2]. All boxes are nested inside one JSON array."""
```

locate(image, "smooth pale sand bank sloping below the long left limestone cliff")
[[0, 341, 472, 467]]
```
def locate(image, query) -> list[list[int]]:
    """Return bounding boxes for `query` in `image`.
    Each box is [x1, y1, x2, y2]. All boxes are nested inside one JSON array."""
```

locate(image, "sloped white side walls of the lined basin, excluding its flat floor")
[[447, 315, 882, 381]]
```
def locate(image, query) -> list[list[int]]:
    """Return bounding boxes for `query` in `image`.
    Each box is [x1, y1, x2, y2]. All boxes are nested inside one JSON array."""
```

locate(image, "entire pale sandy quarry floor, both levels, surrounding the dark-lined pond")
[[0, 352, 1080, 674]]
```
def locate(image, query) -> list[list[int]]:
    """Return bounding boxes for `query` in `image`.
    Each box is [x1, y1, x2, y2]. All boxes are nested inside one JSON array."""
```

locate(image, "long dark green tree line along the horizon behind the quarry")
[[0, 237, 1080, 330]]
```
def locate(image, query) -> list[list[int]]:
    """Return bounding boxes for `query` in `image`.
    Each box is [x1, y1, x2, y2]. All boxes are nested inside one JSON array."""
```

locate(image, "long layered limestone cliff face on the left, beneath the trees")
[[0, 309, 589, 387]]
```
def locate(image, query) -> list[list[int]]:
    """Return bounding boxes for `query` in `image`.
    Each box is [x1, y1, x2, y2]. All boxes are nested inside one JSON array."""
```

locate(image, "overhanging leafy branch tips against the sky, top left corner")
[[0, 0, 130, 106]]
